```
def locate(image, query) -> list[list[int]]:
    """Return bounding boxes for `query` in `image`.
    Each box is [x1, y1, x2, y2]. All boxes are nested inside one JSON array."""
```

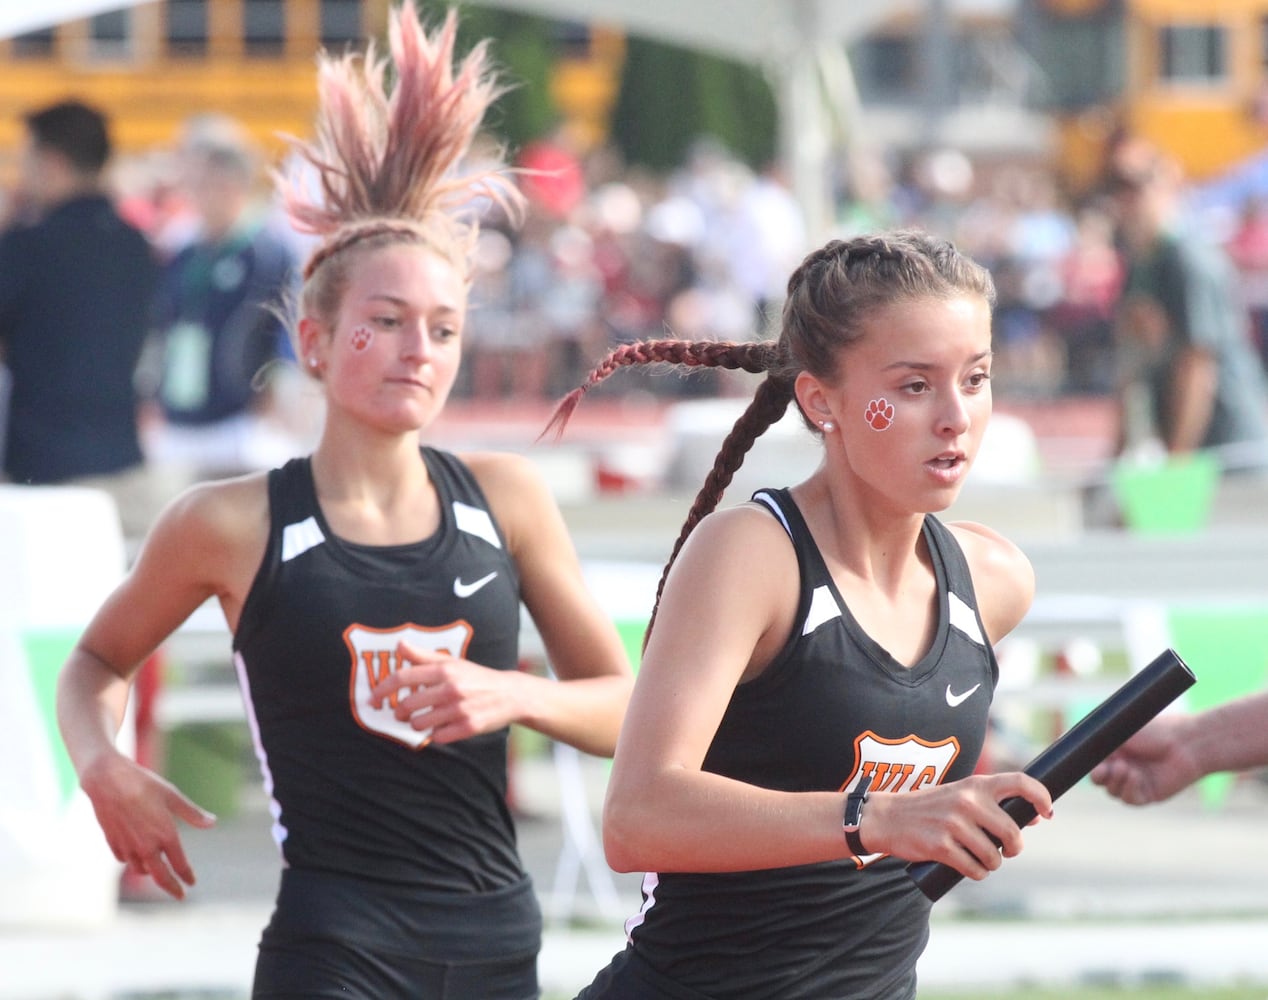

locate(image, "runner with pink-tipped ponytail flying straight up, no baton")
[[58, 5, 631, 1000]]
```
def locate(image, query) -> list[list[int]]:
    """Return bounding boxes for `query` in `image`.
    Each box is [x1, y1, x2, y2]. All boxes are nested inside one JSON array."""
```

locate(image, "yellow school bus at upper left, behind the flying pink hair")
[[0, 0, 387, 179]]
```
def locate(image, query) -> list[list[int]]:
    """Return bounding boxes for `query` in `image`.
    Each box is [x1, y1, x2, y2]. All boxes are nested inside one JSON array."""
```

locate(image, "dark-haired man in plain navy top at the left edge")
[[0, 100, 161, 537]]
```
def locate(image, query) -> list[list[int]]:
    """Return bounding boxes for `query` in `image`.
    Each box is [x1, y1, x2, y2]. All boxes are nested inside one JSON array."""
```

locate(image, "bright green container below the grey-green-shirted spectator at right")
[[1111, 451, 1220, 535]]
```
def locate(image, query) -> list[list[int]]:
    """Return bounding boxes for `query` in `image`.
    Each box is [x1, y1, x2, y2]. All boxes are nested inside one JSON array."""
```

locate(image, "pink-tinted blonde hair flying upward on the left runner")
[[275, 3, 522, 339]]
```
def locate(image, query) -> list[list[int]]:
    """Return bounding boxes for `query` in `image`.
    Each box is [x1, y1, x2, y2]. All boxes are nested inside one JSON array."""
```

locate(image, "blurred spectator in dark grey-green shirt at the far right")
[[1108, 138, 1268, 469]]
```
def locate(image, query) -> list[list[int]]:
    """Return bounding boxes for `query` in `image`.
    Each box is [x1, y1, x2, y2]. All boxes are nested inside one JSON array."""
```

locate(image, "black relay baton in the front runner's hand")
[[907, 649, 1197, 902]]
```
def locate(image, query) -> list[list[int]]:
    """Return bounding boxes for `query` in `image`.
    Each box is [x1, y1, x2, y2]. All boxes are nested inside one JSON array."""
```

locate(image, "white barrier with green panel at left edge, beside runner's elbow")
[[0, 485, 131, 928]]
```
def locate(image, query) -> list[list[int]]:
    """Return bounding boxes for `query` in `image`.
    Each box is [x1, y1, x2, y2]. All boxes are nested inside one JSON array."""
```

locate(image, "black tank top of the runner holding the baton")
[[626, 489, 998, 1000]]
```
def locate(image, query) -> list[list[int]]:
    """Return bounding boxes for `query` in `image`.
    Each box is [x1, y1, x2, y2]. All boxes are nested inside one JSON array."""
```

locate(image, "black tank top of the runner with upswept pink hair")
[[233, 449, 525, 894]]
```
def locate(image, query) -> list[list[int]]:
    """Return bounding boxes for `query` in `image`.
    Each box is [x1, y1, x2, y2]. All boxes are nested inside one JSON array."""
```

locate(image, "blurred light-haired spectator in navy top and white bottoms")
[[147, 117, 297, 479]]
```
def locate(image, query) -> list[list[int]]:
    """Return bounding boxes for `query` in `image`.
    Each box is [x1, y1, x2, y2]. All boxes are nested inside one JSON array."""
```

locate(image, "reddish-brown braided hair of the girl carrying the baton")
[[543, 229, 995, 645]]
